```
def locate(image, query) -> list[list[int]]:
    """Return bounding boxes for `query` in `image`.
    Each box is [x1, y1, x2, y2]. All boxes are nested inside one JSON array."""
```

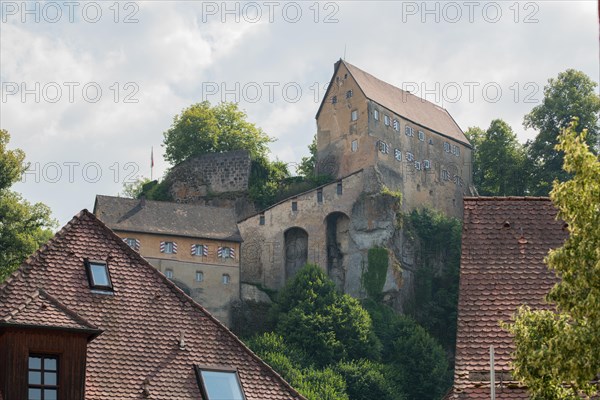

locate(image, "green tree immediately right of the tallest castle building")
[[466, 119, 526, 196]]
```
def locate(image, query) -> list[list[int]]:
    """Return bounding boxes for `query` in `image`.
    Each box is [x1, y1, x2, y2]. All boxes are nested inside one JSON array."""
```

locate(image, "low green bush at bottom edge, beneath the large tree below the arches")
[[335, 359, 406, 400]]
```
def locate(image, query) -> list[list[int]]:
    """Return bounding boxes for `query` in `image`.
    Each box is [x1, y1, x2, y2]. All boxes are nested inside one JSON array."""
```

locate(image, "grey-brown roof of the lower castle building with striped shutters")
[[94, 195, 242, 242]]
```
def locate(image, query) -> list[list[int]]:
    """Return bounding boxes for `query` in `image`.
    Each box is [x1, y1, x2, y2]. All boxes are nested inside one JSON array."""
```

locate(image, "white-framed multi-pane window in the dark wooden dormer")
[[27, 354, 58, 400]]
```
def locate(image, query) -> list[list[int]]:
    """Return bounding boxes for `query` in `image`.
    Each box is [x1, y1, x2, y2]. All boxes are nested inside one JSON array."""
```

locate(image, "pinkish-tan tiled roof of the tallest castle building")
[[317, 60, 470, 146]]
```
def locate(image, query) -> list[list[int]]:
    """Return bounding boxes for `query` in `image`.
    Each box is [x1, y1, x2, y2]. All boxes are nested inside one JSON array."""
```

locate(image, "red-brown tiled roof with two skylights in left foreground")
[[0, 210, 303, 400]]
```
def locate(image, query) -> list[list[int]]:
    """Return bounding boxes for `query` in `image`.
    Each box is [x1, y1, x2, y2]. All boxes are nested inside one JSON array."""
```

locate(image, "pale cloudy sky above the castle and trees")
[[0, 0, 599, 225]]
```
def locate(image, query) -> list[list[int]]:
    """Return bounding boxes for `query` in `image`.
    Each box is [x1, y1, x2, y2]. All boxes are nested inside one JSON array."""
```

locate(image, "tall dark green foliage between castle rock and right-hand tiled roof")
[[404, 208, 462, 351]]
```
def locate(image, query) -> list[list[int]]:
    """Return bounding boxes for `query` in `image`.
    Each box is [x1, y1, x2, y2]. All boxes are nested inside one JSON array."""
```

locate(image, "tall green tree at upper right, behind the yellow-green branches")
[[523, 69, 600, 196]]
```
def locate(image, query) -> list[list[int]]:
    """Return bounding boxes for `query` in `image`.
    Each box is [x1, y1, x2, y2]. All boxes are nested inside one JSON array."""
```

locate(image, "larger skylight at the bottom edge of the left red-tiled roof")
[[196, 367, 246, 400]]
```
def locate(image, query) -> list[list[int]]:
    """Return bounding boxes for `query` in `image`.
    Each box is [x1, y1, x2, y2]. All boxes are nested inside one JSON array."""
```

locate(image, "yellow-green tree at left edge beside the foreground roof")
[[0, 129, 57, 282]]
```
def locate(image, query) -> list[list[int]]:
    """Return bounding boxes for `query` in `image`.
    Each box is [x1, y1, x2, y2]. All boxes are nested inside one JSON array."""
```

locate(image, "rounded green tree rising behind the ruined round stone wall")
[[163, 101, 273, 164]]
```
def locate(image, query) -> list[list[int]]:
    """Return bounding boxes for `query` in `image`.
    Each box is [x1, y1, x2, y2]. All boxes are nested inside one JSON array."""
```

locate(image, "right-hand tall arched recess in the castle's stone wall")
[[325, 212, 350, 292]]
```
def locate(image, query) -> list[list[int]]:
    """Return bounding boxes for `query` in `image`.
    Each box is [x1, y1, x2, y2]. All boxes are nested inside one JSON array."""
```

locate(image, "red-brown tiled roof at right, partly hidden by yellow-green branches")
[[451, 197, 567, 399]]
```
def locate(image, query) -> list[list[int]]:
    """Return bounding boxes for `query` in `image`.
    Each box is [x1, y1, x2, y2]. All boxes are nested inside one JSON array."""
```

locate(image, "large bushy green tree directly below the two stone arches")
[[277, 264, 378, 366]]
